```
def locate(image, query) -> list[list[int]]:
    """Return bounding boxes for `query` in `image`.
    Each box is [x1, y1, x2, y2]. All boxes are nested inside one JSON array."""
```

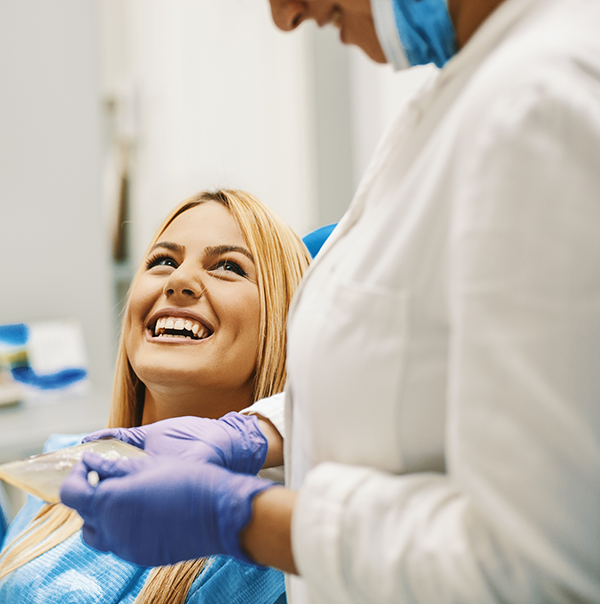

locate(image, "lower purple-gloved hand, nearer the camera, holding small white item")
[[60, 453, 275, 566]]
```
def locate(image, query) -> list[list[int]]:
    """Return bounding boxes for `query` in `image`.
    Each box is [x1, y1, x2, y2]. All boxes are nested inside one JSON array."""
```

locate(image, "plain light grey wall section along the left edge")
[[0, 0, 112, 394]]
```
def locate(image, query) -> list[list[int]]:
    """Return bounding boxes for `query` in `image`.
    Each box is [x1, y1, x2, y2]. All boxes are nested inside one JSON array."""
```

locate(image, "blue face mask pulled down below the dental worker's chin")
[[371, 0, 456, 69]]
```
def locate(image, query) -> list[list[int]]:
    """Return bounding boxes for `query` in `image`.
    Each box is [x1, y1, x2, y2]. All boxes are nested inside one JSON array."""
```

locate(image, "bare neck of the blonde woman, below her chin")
[[142, 386, 252, 425]]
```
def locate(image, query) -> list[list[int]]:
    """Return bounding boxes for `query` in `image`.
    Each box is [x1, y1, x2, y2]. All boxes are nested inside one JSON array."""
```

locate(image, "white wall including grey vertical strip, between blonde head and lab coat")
[[101, 0, 432, 265]]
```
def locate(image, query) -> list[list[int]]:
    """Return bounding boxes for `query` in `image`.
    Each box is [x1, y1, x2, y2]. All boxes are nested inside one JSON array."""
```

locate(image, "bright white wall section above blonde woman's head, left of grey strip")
[[103, 0, 317, 264]]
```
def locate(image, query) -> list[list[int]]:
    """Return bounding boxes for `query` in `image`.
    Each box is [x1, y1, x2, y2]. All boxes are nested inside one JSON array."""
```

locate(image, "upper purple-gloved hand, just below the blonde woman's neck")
[[83, 412, 269, 474]]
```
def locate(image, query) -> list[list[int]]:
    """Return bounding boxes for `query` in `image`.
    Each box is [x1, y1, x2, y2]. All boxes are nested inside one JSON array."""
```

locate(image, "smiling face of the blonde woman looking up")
[[125, 201, 260, 419]]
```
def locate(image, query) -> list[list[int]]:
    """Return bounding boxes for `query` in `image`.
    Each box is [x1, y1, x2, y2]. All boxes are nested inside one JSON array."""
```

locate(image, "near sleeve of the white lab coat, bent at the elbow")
[[292, 76, 600, 604]]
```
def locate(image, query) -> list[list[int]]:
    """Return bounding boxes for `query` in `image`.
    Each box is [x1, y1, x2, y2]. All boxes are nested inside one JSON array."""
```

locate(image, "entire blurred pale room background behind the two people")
[[0, 0, 432, 520]]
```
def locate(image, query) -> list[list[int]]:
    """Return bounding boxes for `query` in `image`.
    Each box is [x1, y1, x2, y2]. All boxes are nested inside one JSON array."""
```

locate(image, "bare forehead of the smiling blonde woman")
[[157, 201, 247, 247]]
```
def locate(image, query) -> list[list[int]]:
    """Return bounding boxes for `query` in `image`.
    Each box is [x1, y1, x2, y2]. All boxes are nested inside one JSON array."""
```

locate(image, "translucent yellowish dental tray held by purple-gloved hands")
[[0, 438, 148, 503]]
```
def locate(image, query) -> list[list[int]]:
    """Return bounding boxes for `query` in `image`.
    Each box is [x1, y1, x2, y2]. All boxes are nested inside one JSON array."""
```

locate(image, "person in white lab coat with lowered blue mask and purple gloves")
[[62, 0, 600, 604]]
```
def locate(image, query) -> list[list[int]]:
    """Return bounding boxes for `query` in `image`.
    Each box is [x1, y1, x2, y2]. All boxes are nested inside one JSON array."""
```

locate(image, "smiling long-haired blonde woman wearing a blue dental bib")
[[0, 190, 309, 604]]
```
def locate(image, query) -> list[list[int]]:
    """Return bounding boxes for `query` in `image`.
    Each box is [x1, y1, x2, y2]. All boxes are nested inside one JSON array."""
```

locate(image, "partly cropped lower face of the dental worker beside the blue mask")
[[270, 0, 386, 63]]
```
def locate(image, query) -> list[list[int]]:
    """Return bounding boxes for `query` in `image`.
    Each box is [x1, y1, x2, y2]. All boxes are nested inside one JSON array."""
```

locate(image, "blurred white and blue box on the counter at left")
[[0, 321, 89, 405]]
